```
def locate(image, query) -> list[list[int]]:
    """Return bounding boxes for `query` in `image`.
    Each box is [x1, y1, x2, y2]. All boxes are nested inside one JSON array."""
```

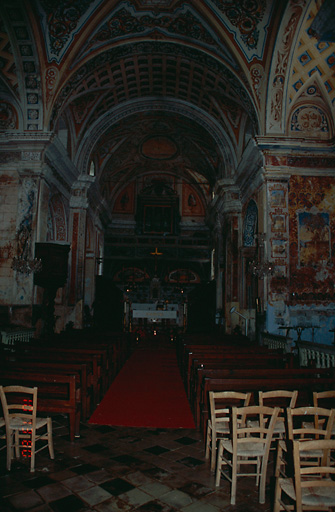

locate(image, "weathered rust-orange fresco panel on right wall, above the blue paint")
[[289, 176, 335, 304]]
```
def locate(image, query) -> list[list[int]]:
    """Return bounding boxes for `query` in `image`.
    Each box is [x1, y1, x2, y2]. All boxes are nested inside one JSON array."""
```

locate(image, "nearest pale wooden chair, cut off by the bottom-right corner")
[[273, 439, 335, 512]]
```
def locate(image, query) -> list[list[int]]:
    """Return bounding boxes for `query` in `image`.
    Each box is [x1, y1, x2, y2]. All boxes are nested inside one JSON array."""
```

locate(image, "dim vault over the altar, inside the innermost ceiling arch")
[[77, 98, 236, 199]]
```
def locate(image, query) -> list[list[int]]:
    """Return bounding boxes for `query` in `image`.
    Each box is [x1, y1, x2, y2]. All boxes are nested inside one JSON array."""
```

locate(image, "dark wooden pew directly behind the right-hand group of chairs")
[[200, 376, 335, 436]]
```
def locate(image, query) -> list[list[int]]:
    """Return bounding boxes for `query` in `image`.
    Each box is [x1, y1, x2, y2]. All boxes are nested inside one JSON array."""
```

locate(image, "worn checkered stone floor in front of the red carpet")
[[0, 416, 273, 512]]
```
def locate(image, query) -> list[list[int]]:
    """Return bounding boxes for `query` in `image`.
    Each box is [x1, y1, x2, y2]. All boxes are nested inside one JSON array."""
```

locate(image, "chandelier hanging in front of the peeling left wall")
[[11, 226, 42, 276]]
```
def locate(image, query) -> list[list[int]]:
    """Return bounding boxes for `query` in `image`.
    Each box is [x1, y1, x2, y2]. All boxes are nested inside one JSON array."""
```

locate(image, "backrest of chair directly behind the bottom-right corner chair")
[[287, 407, 335, 441]]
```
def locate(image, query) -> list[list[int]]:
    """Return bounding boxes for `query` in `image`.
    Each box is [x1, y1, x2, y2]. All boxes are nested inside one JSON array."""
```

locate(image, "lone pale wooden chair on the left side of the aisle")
[[0, 386, 54, 472]]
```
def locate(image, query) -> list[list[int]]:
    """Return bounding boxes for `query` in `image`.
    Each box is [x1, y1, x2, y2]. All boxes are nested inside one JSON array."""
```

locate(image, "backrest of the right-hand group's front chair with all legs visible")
[[232, 405, 280, 452]]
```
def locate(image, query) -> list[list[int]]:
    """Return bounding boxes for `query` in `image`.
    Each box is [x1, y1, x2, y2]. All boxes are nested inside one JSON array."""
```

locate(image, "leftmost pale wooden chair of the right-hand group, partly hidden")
[[205, 391, 251, 472]]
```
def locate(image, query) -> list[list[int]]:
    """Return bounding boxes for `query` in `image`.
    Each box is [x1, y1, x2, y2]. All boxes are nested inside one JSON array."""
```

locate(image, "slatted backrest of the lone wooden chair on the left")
[[0, 386, 37, 430]]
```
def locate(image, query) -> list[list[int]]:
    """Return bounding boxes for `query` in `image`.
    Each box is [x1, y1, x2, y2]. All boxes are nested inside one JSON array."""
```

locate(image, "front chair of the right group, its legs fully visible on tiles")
[[215, 405, 279, 505]]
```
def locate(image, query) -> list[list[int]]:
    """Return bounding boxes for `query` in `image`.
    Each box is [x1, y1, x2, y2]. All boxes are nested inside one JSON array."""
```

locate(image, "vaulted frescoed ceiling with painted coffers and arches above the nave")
[[0, 0, 335, 205]]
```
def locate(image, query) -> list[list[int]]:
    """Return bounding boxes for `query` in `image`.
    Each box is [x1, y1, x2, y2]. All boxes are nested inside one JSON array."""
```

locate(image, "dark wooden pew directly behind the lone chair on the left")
[[0, 370, 81, 441]]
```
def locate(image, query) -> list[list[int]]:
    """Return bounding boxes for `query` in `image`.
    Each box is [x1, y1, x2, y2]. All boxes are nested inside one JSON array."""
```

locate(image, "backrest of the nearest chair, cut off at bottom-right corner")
[[292, 439, 335, 510]]
